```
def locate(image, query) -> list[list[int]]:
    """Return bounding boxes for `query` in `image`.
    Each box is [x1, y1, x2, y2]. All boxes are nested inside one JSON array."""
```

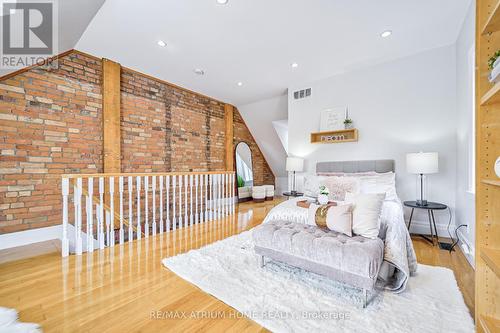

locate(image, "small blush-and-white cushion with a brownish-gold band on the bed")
[[307, 204, 353, 237]]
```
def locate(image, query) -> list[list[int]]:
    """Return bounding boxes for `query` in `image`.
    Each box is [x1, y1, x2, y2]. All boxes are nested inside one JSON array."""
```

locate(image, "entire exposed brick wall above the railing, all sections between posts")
[[0, 52, 274, 234]]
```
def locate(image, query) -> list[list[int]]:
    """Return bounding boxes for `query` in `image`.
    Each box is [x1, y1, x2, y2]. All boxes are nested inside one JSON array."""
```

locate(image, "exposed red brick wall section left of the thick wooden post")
[[0, 54, 102, 233]]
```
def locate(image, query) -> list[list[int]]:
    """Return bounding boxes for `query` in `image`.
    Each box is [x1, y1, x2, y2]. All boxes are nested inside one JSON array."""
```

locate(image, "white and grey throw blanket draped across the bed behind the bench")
[[264, 198, 417, 293]]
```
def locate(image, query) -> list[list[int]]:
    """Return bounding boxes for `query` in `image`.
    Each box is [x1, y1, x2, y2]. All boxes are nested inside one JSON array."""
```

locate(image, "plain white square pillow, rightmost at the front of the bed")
[[346, 193, 385, 238]]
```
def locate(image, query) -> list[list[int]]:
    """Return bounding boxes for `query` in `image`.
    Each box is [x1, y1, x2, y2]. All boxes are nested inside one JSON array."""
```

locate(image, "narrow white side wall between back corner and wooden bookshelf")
[[453, 1, 475, 264]]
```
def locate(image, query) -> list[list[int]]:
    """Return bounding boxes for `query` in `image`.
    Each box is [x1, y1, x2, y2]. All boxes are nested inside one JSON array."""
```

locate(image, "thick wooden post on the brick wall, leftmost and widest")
[[102, 59, 121, 173]]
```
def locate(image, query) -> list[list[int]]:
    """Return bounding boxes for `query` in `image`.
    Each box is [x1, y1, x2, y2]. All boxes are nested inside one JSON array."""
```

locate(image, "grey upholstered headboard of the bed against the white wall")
[[316, 160, 395, 173]]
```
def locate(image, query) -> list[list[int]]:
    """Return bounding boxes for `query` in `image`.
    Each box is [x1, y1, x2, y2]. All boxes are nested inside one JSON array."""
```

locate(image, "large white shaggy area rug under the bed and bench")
[[162, 230, 474, 333]]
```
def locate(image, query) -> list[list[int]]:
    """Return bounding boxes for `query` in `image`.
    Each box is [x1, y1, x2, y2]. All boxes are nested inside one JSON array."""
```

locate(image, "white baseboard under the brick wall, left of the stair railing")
[[0, 224, 62, 250]]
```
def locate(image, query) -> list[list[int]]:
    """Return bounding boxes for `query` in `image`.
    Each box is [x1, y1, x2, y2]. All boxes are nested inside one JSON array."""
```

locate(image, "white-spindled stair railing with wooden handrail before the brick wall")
[[61, 171, 235, 256]]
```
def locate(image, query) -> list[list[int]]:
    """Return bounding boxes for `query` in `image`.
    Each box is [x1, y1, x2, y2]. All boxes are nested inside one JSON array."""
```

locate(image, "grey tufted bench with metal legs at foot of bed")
[[253, 221, 384, 307]]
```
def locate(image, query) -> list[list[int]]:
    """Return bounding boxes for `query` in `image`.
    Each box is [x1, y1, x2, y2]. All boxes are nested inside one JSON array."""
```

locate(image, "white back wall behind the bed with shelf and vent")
[[288, 45, 457, 236]]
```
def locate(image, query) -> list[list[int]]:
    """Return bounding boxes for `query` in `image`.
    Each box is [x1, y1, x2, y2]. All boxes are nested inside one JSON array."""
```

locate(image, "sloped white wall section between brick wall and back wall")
[[237, 94, 288, 194]]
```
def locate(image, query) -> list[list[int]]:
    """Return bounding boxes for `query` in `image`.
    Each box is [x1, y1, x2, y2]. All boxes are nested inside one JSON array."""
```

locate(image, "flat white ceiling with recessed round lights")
[[76, 0, 471, 105]]
